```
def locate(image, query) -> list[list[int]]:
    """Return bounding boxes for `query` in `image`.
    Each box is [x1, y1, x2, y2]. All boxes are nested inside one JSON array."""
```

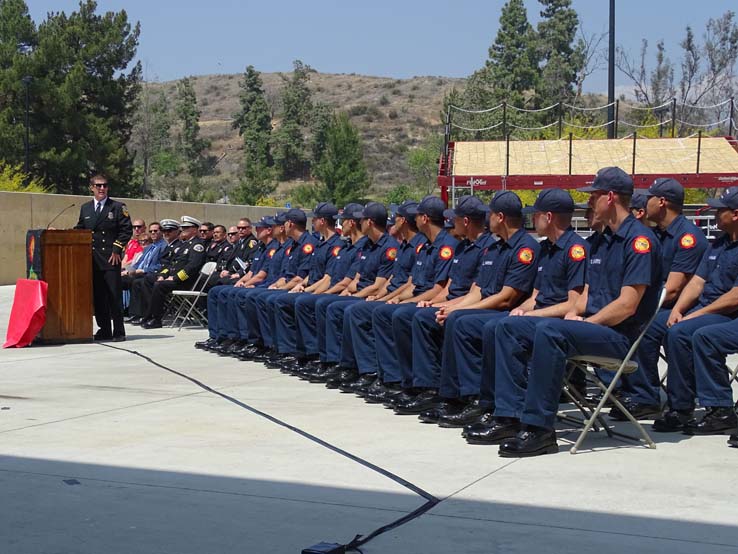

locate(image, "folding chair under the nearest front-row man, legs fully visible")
[[564, 289, 666, 454]]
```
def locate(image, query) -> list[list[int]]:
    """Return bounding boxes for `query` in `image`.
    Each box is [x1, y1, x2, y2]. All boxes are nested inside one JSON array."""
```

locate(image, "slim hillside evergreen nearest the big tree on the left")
[[175, 77, 211, 178]]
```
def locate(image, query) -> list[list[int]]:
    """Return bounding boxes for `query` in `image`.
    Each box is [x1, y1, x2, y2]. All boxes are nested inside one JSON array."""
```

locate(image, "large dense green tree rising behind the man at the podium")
[[17, 0, 141, 195]]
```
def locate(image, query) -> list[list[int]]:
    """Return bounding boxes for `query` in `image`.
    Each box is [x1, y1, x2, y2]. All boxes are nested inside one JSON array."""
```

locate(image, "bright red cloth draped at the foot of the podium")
[[3, 279, 48, 348]]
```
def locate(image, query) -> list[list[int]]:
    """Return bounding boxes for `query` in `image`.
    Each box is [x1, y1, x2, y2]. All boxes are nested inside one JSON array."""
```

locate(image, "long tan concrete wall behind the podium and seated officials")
[[0, 192, 277, 285]]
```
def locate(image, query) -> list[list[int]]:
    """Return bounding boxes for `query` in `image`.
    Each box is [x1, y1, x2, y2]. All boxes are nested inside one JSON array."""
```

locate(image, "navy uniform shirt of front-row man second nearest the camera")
[[533, 227, 589, 309]]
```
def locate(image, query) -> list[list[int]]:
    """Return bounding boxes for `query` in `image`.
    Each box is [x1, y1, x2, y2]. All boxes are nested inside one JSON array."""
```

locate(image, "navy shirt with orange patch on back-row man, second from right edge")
[[656, 214, 709, 283]]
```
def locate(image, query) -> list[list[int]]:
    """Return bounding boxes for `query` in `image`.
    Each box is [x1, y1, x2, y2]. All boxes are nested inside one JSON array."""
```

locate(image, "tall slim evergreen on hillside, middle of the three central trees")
[[272, 60, 313, 179]]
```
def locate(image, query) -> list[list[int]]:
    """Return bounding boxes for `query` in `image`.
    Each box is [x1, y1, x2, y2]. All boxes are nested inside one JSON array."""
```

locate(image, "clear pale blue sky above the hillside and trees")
[[29, 0, 738, 92]]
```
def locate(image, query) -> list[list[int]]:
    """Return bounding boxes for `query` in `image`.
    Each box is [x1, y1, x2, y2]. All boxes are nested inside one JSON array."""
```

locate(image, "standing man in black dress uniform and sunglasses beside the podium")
[[74, 174, 132, 342]]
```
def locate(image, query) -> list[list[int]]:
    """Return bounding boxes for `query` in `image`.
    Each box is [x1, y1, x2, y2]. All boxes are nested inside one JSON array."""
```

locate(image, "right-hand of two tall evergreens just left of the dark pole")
[[537, 0, 584, 105]]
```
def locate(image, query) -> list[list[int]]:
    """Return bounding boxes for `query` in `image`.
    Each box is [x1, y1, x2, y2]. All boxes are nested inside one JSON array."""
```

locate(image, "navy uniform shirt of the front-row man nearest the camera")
[[585, 215, 662, 336]]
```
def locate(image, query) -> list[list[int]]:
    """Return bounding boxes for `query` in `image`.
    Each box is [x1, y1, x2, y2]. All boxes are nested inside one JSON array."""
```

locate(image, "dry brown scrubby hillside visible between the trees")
[[148, 73, 462, 195]]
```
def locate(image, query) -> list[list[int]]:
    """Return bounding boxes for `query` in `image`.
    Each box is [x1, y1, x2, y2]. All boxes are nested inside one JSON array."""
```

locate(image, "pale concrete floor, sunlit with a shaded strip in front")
[[0, 287, 738, 554]]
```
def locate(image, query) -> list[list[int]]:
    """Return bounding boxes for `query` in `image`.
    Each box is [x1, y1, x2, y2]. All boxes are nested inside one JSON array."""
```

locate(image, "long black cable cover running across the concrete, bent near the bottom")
[[100, 343, 440, 552]]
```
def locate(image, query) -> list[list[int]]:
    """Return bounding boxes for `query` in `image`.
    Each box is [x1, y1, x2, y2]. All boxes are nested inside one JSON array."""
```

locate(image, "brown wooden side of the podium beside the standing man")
[[40, 229, 93, 344]]
